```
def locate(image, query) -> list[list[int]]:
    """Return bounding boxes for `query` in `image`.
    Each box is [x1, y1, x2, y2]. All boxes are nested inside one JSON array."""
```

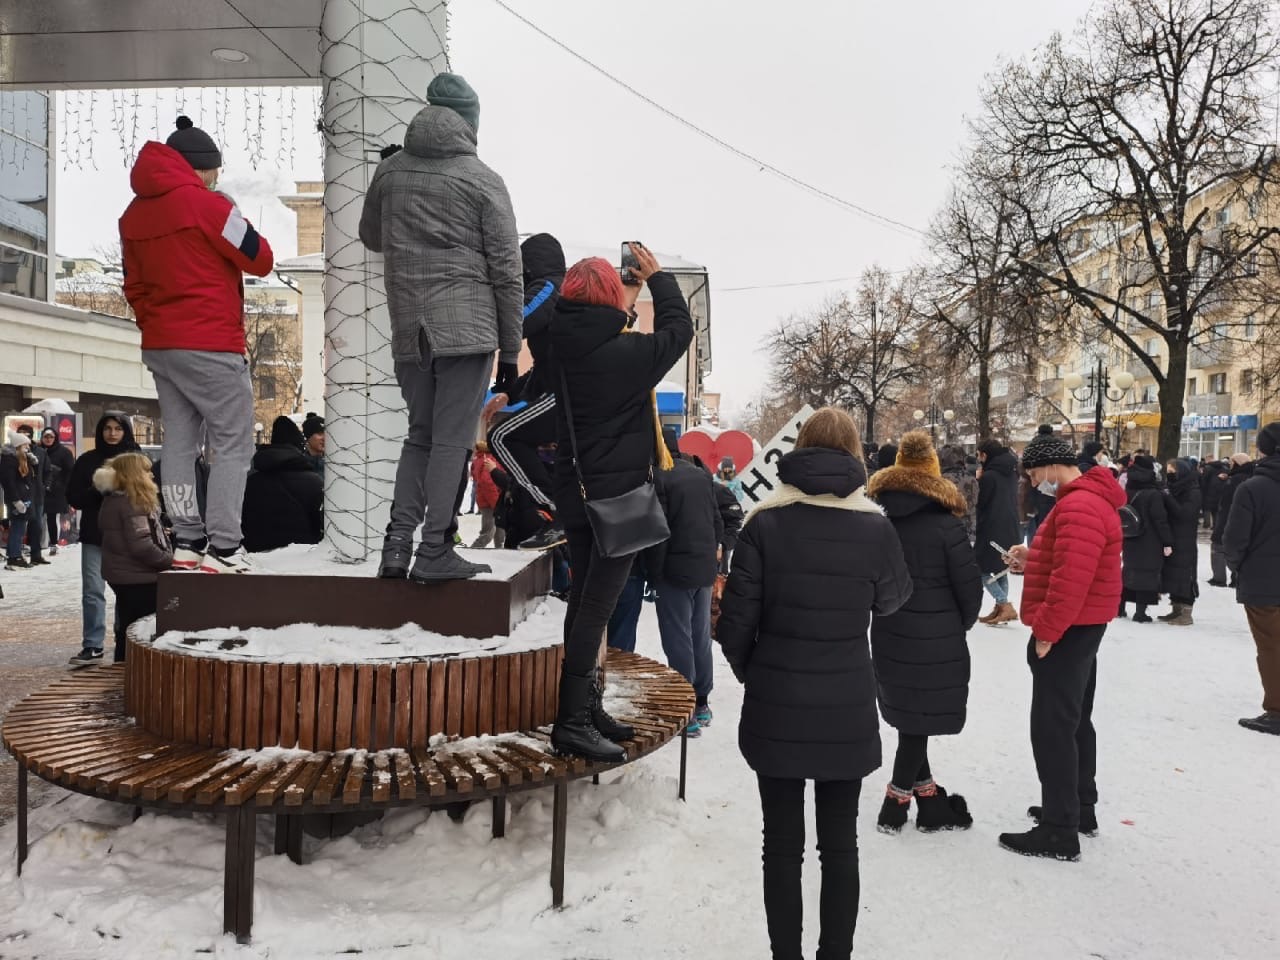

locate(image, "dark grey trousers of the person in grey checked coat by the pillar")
[[387, 337, 493, 547]]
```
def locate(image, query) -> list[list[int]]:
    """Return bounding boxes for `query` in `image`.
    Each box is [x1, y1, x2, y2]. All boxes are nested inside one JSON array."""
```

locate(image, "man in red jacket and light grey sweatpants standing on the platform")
[[120, 116, 274, 573]]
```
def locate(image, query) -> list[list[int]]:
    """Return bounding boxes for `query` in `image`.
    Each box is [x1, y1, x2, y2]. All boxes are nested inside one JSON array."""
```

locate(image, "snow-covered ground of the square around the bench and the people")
[[0, 527, 1280, 960]]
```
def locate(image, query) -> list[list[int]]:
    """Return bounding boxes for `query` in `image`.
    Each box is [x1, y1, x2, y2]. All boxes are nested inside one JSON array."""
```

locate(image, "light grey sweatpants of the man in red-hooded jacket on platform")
[[142, 349, 253, 550]]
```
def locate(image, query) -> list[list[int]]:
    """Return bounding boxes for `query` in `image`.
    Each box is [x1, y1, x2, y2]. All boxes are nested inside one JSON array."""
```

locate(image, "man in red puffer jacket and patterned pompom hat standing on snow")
[[1000, 434, 1125, 860]]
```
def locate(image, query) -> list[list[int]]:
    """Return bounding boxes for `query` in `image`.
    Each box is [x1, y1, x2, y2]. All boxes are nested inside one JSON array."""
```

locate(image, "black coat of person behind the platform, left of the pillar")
[[241, 444, 324, 553]]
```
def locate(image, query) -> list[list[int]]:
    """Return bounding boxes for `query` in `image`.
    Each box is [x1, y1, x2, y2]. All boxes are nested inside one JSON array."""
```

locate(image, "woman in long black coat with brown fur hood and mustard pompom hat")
[[867, 430, 982, 833]]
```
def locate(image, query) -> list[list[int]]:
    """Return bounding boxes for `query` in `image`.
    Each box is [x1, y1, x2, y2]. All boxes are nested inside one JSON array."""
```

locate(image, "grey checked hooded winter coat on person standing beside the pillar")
[[360, 106, 525, 364]]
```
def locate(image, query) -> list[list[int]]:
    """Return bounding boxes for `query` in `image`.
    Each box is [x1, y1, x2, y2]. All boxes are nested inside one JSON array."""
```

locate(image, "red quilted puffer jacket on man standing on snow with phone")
[[1021, 467, 1125, 644]]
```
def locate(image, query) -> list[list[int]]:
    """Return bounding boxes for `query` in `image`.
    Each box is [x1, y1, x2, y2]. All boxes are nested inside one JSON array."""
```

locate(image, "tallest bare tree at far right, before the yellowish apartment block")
[[975, 0, 1277, 458]]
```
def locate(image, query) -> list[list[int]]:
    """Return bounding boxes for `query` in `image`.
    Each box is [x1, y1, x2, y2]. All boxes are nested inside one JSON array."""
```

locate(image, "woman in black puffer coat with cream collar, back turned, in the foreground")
[[716, 407, 911, 957]]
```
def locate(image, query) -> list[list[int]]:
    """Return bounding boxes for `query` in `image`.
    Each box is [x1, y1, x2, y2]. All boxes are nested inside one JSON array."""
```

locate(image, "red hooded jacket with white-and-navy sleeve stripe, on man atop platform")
[[120, 141, 274, 353]]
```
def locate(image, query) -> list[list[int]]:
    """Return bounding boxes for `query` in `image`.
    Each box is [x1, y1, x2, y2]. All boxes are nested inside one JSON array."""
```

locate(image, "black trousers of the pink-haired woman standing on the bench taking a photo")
[[564, 526, 634, 677]]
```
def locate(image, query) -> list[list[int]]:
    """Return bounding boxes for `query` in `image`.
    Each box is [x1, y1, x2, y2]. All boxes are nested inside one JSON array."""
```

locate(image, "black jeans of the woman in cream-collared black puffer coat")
[[759, 776, 863, 960]]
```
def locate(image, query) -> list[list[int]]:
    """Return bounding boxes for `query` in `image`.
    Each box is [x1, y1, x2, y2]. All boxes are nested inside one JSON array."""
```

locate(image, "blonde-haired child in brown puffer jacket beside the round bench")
[[93, 453, 173, 663]]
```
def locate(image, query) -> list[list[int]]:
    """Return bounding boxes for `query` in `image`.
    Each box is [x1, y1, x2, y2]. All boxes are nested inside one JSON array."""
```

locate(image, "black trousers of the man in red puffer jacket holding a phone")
[[1027, 623, 1107, 829]]
